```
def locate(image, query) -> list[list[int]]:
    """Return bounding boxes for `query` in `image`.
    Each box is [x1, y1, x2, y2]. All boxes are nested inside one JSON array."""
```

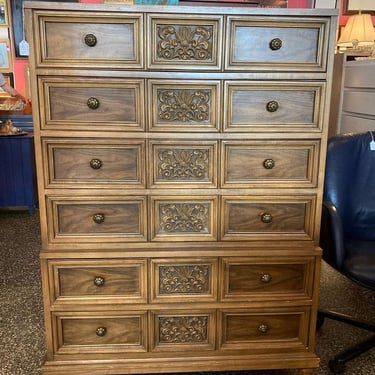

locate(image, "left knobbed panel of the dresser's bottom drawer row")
[[52, 311, 147, 354]]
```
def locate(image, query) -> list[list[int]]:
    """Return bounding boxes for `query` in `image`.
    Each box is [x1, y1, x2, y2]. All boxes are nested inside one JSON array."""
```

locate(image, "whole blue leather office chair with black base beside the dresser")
[[318, 130, 375, 374]]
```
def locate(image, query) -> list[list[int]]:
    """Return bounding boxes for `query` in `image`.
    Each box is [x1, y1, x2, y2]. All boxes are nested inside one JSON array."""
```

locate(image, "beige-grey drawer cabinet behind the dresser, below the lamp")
[[329, 53, 375, 136]]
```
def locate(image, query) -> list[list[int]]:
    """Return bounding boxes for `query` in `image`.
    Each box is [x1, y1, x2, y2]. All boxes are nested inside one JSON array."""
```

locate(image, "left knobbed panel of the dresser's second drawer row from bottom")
[[48, 259, 147, 305]]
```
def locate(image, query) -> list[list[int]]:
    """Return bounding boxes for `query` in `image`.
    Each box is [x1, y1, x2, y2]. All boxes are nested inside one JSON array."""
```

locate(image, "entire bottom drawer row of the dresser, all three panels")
[[52, 306, 310, 355]]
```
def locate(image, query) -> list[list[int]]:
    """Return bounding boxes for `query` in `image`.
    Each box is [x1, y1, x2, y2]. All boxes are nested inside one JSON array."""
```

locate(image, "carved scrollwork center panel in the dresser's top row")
[[147, 13, 223, 70]]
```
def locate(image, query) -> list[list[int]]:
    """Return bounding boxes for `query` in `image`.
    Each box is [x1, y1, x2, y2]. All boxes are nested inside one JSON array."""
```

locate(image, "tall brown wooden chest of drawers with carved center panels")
[[25, 2, 336, 375]]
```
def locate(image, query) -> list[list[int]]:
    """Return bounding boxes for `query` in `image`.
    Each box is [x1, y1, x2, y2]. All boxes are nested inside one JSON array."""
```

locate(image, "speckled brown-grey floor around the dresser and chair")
[[0, 210, 375, 375]]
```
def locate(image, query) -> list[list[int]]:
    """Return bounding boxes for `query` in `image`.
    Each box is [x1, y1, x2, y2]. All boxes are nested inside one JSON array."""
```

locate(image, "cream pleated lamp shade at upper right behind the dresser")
[[337, 13, 375, 47]]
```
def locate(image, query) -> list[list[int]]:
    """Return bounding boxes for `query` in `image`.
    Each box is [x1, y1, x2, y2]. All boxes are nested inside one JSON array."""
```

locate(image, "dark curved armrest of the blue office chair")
[[320, 201, 345, 269]]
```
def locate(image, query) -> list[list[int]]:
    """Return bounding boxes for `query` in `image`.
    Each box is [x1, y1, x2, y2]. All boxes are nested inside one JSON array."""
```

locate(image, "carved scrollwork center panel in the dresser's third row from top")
[[149, 140, 218, 188]]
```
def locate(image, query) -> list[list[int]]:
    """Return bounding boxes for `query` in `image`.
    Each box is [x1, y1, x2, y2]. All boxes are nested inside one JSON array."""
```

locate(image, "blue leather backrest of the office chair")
[[324, 130, 375, 240]]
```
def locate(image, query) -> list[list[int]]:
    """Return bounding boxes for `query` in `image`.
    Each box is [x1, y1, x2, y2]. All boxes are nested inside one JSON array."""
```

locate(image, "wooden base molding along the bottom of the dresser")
[[42, 352, 319, 375]]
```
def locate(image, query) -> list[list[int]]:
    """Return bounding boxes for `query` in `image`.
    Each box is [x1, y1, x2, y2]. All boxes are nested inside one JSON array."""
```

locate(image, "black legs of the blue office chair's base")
[[317, 310, 375, 374]]
